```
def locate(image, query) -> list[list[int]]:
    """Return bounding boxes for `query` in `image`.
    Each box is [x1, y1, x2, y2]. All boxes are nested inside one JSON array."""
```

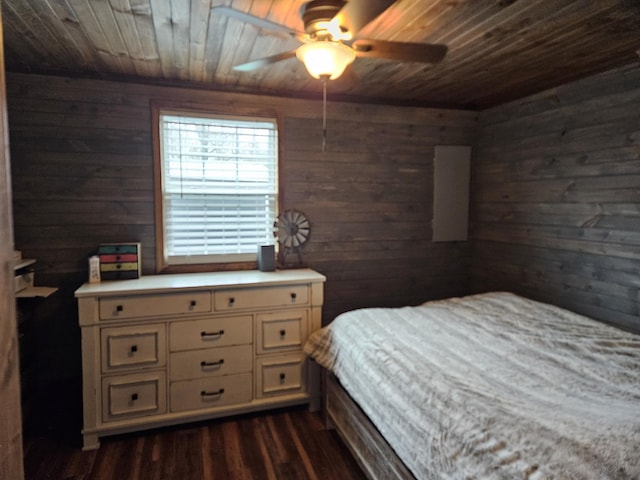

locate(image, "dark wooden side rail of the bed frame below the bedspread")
[[323, 370, 415, 480]]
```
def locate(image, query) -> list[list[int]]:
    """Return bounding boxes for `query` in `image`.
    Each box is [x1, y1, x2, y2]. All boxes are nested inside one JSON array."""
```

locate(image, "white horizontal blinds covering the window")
[[160, 112, 278, 265]]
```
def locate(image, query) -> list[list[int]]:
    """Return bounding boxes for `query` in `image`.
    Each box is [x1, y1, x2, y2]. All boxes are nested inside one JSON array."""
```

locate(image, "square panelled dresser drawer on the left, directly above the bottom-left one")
[[100, 324, 166, 373]]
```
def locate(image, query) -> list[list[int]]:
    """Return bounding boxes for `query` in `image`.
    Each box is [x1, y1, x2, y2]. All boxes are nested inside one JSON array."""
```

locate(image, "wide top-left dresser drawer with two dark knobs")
[[100, 292, 211, 320]]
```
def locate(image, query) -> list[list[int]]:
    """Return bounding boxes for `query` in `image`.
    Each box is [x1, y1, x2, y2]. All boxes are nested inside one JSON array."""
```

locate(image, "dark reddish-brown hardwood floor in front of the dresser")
[[24, 408, 364, 480]]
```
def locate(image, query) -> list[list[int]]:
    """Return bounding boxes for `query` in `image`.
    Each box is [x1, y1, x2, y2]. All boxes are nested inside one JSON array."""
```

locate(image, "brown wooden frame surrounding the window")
[[151, 100, 284, 273]]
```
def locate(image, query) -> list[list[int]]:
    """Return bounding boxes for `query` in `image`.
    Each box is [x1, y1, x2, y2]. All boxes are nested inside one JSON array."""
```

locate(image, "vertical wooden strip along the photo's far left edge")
[[0, 5, 24, 480]]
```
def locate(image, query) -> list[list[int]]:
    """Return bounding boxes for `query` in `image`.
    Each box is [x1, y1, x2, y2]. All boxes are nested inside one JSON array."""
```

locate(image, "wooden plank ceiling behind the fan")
[[2, 0, 640, 109]]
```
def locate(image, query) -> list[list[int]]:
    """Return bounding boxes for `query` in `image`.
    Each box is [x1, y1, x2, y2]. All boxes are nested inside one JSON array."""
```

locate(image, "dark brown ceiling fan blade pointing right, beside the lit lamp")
[[351, 39, 447, 63]]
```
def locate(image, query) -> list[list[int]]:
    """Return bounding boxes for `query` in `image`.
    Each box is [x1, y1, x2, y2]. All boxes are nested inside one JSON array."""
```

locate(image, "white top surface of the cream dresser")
[[75, 268, 326, 298]]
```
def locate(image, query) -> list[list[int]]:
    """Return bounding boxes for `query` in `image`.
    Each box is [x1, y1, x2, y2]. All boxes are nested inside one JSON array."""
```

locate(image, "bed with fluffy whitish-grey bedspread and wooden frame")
[[305, 292, 640, 480]]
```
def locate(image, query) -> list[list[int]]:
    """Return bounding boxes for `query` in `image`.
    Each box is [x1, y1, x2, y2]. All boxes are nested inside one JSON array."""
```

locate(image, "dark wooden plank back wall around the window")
[[8, 74, 477, 404]]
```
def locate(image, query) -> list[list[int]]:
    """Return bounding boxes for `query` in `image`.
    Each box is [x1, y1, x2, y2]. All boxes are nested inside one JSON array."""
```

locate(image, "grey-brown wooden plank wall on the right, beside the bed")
[[471, 64, 640, 330]]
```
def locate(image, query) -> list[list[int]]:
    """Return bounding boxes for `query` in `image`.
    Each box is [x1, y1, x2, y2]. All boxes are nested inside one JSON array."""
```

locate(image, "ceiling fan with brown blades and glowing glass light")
[[213, 0, 447, 80]]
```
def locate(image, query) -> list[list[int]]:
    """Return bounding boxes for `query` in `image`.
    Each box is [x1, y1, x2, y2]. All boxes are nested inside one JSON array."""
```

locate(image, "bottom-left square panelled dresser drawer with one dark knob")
[[102, 372, 167, 422]]
